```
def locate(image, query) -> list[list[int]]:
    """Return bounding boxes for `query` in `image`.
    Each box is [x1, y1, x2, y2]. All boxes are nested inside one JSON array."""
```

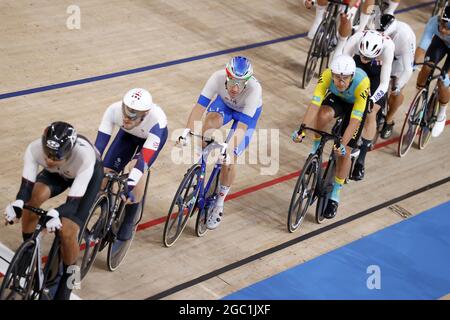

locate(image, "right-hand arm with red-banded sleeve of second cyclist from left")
[[128, 123, 167, 188]]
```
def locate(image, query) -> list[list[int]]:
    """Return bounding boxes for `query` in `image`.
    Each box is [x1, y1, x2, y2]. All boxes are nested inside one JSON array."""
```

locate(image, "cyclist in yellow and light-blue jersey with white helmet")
[[292, 55, 370, 219]]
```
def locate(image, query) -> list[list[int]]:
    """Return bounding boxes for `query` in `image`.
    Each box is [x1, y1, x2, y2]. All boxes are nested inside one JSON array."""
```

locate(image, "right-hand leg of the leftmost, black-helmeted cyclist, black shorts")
[[54, 160, 103, 300]]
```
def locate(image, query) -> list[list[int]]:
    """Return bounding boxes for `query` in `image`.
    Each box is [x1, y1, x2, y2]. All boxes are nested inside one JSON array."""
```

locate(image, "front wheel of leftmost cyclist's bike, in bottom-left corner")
[[0, 239, 37, 300]]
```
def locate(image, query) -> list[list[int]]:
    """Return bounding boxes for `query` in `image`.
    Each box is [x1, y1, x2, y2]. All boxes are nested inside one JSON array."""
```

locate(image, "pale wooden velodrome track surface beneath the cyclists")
[[0, 0, 450, 299]]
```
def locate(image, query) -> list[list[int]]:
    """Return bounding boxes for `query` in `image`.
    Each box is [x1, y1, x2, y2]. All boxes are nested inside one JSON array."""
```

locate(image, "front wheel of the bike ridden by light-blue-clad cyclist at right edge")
[[397, 89, 426, 157]]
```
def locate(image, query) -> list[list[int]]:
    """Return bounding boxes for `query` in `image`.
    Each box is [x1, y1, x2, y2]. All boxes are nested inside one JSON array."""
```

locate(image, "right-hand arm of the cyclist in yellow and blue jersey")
[[342, 77, 370, 146]]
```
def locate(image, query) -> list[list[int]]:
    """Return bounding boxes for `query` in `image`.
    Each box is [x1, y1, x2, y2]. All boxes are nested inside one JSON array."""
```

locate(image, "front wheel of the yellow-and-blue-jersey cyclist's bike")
[[287, 154, 320, 232]]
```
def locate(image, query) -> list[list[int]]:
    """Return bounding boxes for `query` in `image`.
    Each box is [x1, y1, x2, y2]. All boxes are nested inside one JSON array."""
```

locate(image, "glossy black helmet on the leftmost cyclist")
[[42, 121, 77, 160]]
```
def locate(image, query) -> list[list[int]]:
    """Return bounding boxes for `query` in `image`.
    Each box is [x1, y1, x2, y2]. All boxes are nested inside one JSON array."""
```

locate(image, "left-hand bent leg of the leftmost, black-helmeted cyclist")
[[22, 169, 69, 240]]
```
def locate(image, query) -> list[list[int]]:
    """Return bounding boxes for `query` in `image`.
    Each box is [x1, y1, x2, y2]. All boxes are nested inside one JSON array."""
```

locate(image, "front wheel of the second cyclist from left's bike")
[[77, 195, 108, 280]]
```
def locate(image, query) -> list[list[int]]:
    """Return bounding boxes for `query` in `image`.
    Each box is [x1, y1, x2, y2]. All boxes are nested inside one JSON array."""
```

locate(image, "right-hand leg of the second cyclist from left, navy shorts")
[[117, 128, 168, 241]]
